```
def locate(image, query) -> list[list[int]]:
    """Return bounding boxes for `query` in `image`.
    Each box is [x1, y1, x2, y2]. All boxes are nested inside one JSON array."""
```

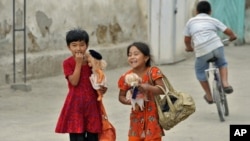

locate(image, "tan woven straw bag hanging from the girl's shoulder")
[[149, 68, 196, 130]]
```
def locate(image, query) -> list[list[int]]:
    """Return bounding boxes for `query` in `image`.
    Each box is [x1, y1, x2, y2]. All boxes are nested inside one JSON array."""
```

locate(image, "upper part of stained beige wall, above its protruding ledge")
[[0, 0, 147, 52]]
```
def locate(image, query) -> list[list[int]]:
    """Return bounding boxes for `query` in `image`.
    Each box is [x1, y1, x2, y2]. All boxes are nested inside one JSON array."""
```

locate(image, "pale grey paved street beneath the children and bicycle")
[[0, 45, 250, 141]]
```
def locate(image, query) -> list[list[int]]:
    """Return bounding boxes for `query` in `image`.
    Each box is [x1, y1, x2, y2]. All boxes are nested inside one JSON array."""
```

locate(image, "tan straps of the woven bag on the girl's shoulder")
[[148, 67, 176, 112]]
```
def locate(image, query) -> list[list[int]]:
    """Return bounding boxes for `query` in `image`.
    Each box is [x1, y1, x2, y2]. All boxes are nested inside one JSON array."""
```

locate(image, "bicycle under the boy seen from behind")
[[205, 39, 229, 121]]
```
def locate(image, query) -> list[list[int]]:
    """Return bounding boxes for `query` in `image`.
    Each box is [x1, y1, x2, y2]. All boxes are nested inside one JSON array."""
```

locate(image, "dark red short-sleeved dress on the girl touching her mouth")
[[55, 57, 102, 133]]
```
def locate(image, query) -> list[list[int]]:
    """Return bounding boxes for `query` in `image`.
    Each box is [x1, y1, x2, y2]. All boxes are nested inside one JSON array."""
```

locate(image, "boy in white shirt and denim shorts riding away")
[[184, 1, 237, 104]]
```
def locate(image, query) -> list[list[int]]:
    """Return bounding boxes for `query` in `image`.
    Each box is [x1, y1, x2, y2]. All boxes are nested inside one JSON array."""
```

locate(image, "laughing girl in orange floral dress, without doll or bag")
[[118, 42, 167, 141]]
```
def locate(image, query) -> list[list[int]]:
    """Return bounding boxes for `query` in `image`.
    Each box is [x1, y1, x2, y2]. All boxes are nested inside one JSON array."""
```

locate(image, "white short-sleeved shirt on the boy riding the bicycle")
[[184, 13, 227, 57]]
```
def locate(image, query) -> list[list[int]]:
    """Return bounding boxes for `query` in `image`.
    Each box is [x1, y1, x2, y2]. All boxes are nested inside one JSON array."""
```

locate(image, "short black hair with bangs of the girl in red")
[[66, 28, 89, 46]]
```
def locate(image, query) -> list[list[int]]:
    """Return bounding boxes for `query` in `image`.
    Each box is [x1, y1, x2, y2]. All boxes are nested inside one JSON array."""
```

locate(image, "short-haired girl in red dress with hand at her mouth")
[[55, 28, 107, 141]]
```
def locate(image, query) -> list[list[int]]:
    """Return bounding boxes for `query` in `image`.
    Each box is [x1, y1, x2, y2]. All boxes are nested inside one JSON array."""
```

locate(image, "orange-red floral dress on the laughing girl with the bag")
[[118, 67, 164, 141]]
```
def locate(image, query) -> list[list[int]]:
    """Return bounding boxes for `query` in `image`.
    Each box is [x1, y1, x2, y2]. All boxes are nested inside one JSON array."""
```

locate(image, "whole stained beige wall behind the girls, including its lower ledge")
[[0, 0, 147, 85]]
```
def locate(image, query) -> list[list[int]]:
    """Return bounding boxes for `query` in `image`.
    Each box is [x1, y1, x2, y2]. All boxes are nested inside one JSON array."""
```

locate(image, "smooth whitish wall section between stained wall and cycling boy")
[[149, 0, 195, 64]]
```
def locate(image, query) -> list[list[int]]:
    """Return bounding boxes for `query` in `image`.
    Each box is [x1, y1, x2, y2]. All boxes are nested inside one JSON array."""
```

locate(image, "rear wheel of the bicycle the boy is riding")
[[213, 80, 225, 121]]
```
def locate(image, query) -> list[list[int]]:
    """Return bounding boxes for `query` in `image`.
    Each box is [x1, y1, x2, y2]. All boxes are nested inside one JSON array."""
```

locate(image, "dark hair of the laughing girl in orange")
[[127, 42, 152, 67]]
